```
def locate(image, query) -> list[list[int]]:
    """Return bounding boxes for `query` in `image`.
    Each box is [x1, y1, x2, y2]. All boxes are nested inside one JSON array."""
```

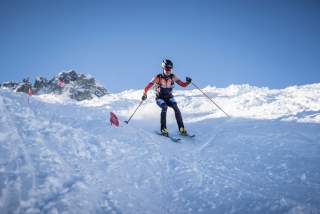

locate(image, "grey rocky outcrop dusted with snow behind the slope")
[[0, 70, 108, 101]]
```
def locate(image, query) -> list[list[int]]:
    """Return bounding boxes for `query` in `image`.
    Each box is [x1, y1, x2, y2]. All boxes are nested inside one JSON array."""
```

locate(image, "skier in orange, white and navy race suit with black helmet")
[[142, 59, 192, 136]]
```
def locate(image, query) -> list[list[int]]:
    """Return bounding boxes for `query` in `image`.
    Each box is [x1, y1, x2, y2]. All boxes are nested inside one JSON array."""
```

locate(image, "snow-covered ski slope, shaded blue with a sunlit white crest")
[[0, 84, 320, 214]]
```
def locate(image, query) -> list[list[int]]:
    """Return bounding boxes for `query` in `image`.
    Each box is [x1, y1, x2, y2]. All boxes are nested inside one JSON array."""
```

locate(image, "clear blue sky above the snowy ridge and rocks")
[[0, 0, 320, 92]]
